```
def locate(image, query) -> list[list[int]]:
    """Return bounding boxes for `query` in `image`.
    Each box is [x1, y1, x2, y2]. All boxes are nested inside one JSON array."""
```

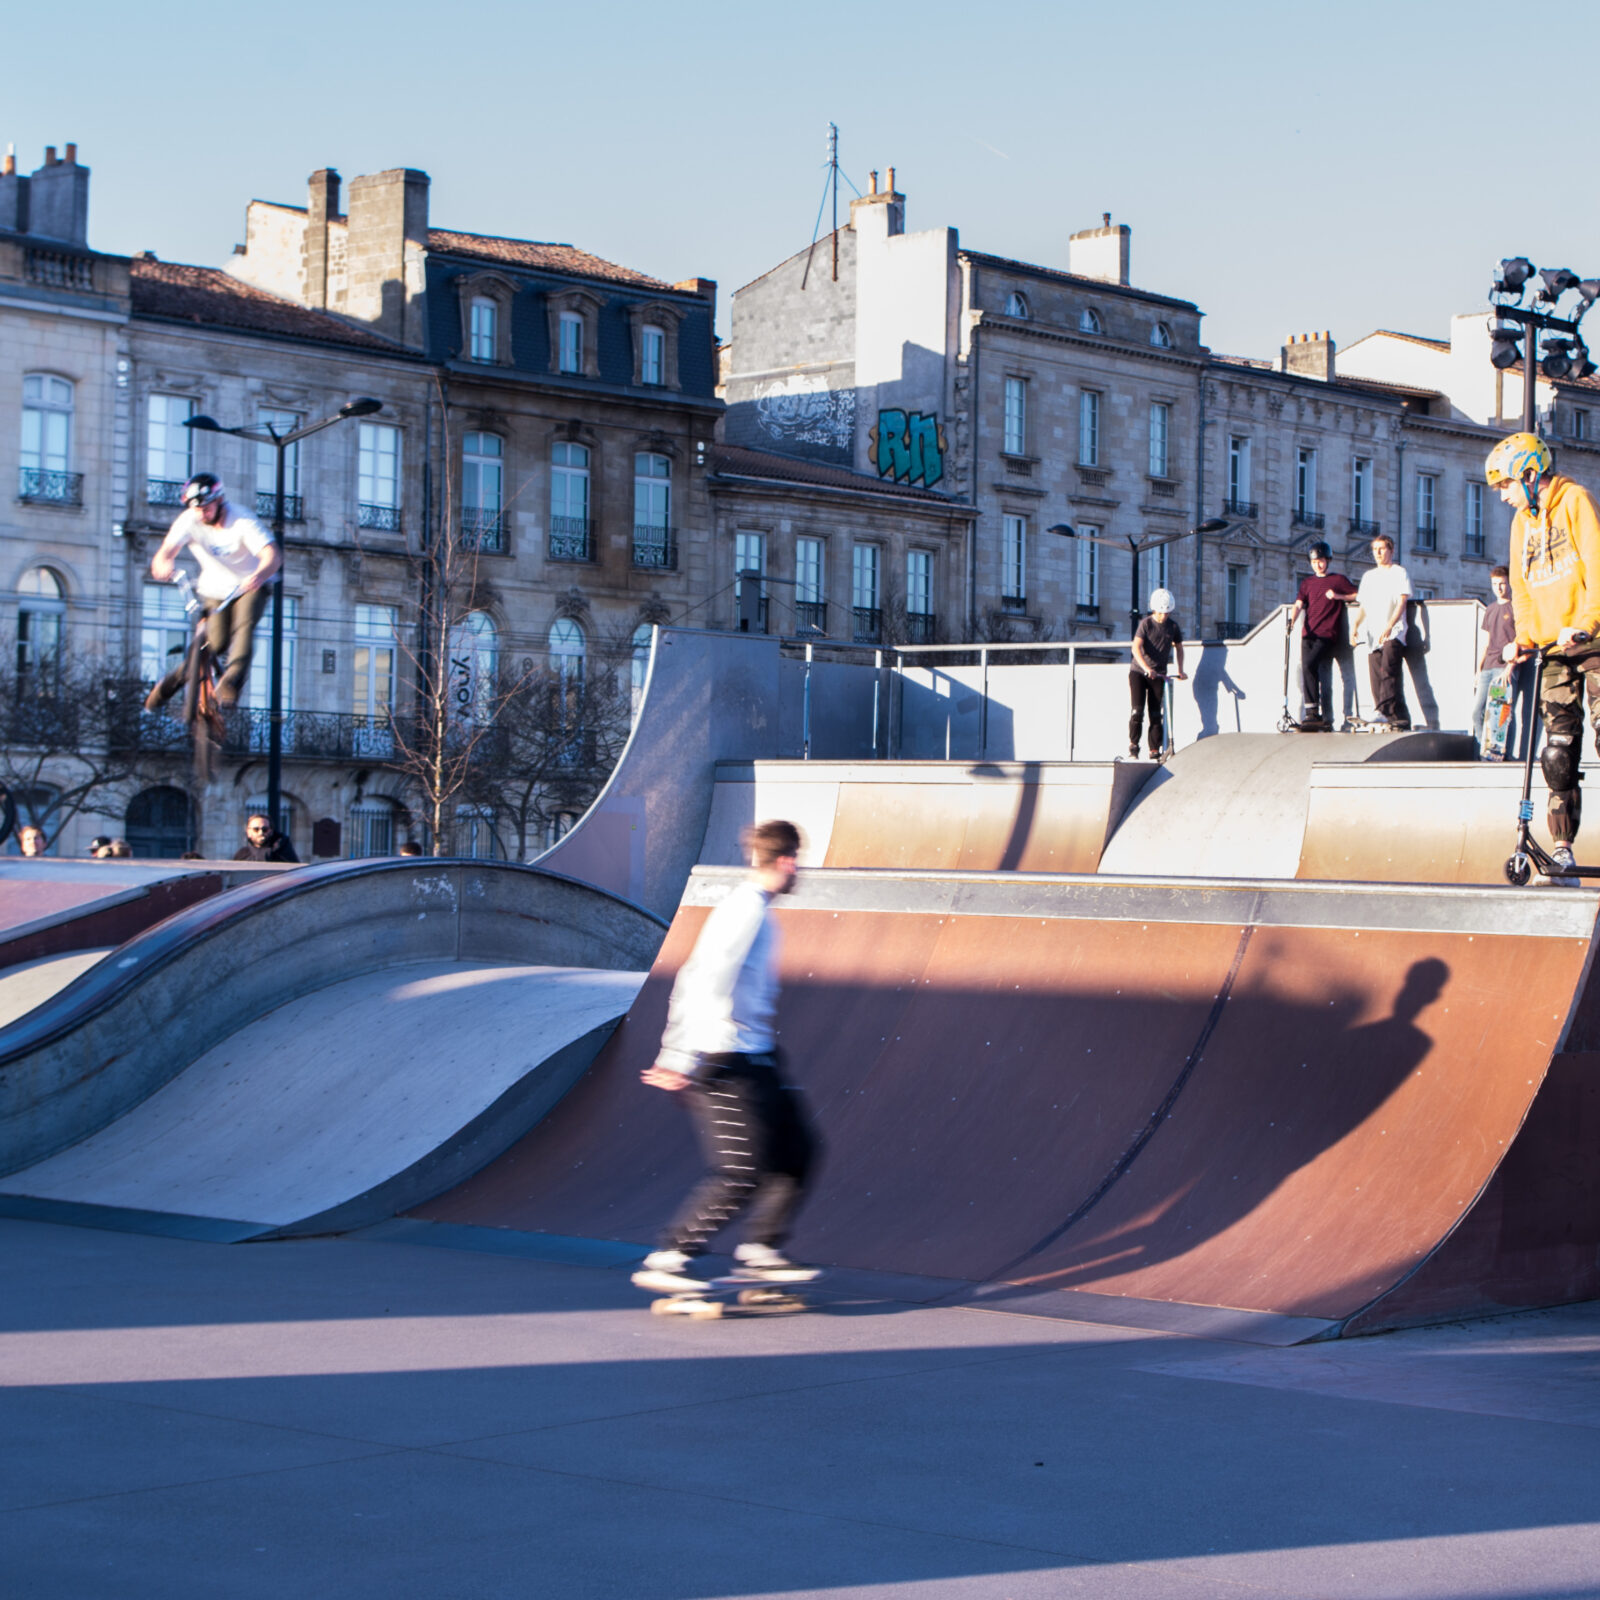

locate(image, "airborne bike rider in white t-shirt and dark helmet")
[[144, 472, 283, 710]]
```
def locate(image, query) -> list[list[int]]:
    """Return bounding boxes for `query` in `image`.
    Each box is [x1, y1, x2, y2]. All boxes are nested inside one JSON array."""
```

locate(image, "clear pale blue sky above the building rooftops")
[[12, 0, 1600, 355]]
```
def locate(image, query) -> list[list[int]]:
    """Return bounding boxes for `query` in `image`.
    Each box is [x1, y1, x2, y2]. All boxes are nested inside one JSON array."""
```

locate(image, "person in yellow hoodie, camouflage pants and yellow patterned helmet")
[[1485, 434, 1600, 883]]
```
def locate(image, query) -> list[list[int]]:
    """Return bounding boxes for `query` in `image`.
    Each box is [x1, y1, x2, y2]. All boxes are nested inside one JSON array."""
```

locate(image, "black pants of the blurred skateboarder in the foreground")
[[661, 1054, 818, 1256]]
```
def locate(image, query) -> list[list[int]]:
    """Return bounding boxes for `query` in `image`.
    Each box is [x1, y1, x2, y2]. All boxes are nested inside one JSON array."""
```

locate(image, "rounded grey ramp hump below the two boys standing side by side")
[[1099, 731, 1472, 882]]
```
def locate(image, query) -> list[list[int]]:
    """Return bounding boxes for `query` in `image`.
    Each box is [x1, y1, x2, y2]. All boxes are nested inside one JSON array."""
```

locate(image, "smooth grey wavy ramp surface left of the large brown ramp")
[[0, 962, 645, 1232]]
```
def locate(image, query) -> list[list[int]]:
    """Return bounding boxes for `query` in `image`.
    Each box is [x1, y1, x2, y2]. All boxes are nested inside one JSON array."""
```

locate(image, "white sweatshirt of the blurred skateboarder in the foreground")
[[658, 882, 778, 1077]]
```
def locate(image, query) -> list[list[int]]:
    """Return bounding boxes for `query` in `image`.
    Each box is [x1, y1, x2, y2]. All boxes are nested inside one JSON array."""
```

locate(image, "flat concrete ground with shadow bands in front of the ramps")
[[0, 1221, 1600, 1600]]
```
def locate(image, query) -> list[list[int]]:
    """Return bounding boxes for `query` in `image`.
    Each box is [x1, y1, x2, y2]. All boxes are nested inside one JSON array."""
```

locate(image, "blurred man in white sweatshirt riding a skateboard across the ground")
[[634, 821, 819, 1294]]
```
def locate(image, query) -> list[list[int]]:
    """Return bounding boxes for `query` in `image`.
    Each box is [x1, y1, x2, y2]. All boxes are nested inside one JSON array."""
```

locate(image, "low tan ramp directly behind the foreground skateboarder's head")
[[701, 762, 1157, 872]]
